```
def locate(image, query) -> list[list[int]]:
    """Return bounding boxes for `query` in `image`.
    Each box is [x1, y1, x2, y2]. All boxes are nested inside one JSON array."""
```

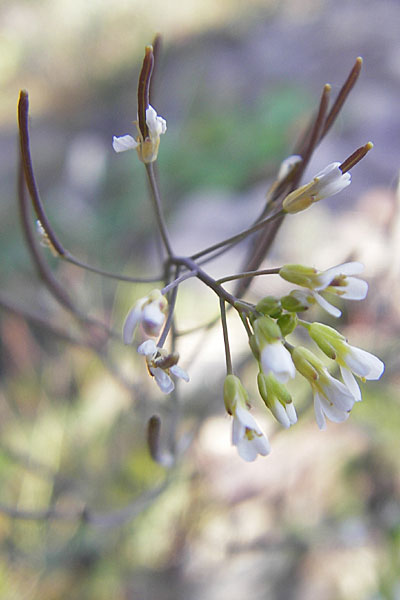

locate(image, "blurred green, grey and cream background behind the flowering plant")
[[0, 0, 400, 600]]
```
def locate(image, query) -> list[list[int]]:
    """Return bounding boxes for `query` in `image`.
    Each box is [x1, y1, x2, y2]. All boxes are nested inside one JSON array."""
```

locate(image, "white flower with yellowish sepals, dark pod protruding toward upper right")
[[282, 162, 351, 213]]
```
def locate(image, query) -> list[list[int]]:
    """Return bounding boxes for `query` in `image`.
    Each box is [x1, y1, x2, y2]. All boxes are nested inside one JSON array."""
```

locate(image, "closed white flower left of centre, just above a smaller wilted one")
[[123, 290, 168, 344]]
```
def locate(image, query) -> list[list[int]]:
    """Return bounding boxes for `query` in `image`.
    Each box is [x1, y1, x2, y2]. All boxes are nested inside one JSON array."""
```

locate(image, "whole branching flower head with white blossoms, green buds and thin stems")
[[111, 46, 384, 461]]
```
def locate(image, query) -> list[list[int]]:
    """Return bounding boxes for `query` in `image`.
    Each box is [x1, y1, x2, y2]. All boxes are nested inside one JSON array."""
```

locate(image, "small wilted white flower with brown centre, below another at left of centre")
[[137, 340, 189, 394]]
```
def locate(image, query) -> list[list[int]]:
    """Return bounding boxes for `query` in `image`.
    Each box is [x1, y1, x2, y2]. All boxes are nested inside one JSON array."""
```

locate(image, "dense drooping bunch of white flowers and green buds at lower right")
[[224, 262, 384, 460]]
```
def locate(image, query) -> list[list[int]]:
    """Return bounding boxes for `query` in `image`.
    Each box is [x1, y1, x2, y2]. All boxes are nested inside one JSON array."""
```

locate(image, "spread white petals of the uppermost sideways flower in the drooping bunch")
[[313, 262, 368, 317]]
